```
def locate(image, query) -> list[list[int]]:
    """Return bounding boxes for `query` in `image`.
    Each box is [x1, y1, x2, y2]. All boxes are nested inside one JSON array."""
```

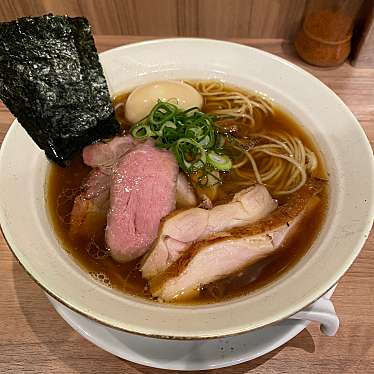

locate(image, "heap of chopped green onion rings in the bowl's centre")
[[130, 101, 232, 186]]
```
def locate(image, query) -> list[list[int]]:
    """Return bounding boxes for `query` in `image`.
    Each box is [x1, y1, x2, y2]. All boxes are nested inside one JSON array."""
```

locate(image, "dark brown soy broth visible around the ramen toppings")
[[47, 82, 327, 304]]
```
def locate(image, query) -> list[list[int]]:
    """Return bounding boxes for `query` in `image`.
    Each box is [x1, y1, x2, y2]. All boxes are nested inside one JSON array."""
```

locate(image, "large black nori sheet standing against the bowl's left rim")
[[0, 15, 120, 166]]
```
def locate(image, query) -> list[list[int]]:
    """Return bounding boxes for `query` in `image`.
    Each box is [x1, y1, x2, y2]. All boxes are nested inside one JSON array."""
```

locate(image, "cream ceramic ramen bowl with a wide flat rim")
[[0, 39, 374, 338]]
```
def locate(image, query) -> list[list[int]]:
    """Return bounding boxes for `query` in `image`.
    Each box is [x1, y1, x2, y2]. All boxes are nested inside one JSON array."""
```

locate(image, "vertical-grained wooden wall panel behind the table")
[[0, 0, 374, 66]]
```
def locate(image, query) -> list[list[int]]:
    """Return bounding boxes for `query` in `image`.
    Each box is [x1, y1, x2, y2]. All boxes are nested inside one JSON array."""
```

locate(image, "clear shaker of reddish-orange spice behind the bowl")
[[295, 0, 363, 66]]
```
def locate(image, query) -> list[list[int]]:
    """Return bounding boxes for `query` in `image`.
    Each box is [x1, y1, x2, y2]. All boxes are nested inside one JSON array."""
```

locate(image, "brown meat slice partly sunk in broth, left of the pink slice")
[[69, 168, 110, 239]]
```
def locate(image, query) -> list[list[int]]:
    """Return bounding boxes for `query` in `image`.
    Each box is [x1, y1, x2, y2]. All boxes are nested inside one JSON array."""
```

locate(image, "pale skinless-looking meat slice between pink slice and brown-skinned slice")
[[141, 184, 277, 279]]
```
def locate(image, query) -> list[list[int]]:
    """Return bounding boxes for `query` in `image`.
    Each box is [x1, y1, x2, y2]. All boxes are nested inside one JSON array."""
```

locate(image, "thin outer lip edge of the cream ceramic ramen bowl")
[[0, 38, 374, 339]]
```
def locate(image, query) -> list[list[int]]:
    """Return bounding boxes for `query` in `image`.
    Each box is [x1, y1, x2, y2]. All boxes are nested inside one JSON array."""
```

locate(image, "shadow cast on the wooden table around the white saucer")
[[13, 261, 315, 374]]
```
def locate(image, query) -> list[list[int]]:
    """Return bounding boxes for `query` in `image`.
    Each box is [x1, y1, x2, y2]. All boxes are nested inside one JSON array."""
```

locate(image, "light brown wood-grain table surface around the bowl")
[[0, 36, 374, 374]]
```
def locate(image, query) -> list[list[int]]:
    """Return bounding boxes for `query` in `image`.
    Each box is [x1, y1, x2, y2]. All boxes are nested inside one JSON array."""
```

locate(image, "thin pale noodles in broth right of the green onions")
[[189, 81, 318, 196]]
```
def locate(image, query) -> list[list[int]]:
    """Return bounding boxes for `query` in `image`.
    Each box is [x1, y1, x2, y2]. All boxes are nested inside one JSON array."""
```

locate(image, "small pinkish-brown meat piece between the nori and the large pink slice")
[[82, 135, 135, 172]]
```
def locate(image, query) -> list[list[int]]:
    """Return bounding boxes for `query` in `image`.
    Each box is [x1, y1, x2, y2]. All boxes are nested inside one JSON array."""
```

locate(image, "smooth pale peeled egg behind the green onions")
[[125, 81, 203, 123]]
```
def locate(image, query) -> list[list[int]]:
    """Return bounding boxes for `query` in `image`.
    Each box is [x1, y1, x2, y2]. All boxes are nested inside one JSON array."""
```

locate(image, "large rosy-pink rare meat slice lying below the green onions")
[[105, 140, 179, 262]]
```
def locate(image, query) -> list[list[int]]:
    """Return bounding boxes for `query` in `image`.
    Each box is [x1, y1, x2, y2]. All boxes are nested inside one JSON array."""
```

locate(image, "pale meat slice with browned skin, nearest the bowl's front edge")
[[150, 180, 323, 301]]
